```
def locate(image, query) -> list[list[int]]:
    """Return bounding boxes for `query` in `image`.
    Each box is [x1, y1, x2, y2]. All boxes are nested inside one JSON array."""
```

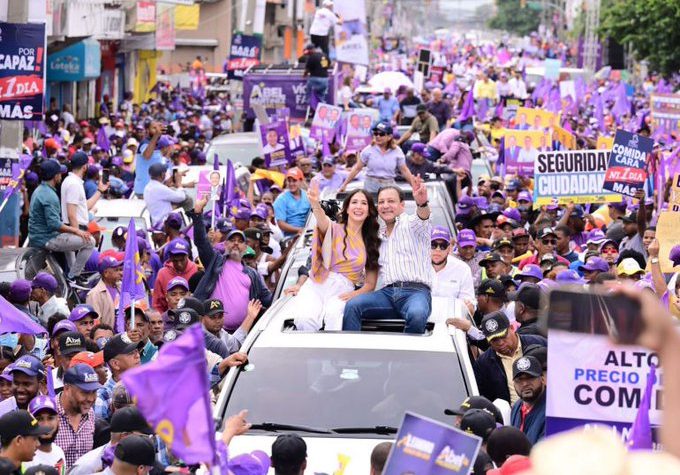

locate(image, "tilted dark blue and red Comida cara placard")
[[602, 130, 654, 196]]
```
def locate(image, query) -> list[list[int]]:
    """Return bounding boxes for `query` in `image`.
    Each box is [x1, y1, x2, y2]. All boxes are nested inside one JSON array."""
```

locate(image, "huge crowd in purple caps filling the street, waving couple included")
[[0, 14, 680, 475]]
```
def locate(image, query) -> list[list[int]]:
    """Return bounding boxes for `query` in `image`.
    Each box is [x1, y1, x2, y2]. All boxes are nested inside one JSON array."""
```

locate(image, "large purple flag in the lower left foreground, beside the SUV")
[[121, 323, 216, 464]]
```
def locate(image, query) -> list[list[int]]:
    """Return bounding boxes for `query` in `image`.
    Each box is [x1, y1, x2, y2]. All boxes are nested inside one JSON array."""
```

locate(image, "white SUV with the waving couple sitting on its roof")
[[214, 297, 478, 474]]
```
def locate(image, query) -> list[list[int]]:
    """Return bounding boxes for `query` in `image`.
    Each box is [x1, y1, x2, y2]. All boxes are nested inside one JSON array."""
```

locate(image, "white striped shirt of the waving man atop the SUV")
[[378, 213, 434, 288]]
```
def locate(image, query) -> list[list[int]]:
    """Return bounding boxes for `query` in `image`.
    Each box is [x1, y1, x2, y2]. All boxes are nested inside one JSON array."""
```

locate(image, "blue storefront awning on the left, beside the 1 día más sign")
[[47, 38, 101, 82]]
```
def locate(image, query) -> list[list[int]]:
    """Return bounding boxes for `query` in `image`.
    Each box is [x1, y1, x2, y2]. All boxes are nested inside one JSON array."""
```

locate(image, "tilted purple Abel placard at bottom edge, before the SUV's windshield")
[[383, 412, 482, 475]]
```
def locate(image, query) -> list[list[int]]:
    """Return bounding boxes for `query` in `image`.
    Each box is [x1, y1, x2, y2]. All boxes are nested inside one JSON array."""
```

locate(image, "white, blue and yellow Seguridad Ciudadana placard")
[[534, 150, 622, 208]]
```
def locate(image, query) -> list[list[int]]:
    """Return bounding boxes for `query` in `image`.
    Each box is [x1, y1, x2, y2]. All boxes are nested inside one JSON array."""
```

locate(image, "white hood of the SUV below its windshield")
[[229, 435, 390, 475]]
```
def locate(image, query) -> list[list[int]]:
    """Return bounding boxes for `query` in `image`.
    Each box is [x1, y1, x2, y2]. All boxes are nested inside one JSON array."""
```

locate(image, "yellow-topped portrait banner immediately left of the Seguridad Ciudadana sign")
[[503, 129, 552, 176]]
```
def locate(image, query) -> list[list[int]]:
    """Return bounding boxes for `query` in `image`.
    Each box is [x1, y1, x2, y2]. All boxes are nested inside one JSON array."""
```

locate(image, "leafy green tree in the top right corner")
[[600, 0, 680, 76]]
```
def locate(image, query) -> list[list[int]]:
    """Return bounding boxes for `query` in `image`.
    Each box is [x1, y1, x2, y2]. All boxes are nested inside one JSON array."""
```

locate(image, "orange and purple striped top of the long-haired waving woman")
[[312, 223, 366, 285]]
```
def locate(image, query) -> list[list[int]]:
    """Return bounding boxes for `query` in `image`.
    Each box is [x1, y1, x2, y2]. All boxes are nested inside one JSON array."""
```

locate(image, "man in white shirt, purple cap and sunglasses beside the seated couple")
[[430, 226, 476, 304]]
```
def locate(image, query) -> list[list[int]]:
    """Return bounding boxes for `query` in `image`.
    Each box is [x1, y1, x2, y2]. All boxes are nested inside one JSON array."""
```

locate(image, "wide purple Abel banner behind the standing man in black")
[[243, 70, 337, 119]]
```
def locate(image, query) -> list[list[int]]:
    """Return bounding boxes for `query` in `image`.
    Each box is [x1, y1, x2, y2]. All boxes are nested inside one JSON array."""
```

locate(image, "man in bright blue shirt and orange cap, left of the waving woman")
[[274, 167, 310, 237]]
